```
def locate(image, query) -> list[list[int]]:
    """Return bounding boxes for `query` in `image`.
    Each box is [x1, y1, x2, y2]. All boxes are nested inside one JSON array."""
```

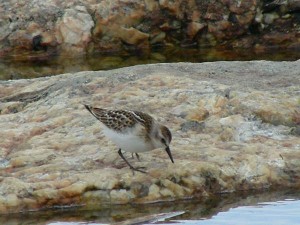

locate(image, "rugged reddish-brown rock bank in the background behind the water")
[[0, 0, 299, 57]]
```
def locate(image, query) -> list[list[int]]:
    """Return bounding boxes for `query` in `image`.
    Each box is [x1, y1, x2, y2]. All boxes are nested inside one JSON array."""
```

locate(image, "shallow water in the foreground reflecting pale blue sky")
[[0, 191, 300, 225]]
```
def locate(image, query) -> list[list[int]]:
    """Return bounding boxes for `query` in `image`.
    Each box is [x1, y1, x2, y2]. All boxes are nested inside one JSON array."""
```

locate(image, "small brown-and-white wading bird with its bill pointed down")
[[84, 105, 174, 173]]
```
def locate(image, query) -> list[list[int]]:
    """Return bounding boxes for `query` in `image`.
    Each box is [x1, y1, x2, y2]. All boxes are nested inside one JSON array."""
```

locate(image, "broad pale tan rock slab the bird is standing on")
[[0, 60, 300, 213]]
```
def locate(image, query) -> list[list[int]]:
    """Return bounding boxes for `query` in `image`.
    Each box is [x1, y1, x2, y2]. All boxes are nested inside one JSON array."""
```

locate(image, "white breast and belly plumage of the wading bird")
[[103, 127, 154, 153]]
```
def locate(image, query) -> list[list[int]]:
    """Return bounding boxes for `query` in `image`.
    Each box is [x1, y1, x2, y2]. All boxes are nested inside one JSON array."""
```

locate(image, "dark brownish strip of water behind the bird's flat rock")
[[0, 48, 300, 80]]
